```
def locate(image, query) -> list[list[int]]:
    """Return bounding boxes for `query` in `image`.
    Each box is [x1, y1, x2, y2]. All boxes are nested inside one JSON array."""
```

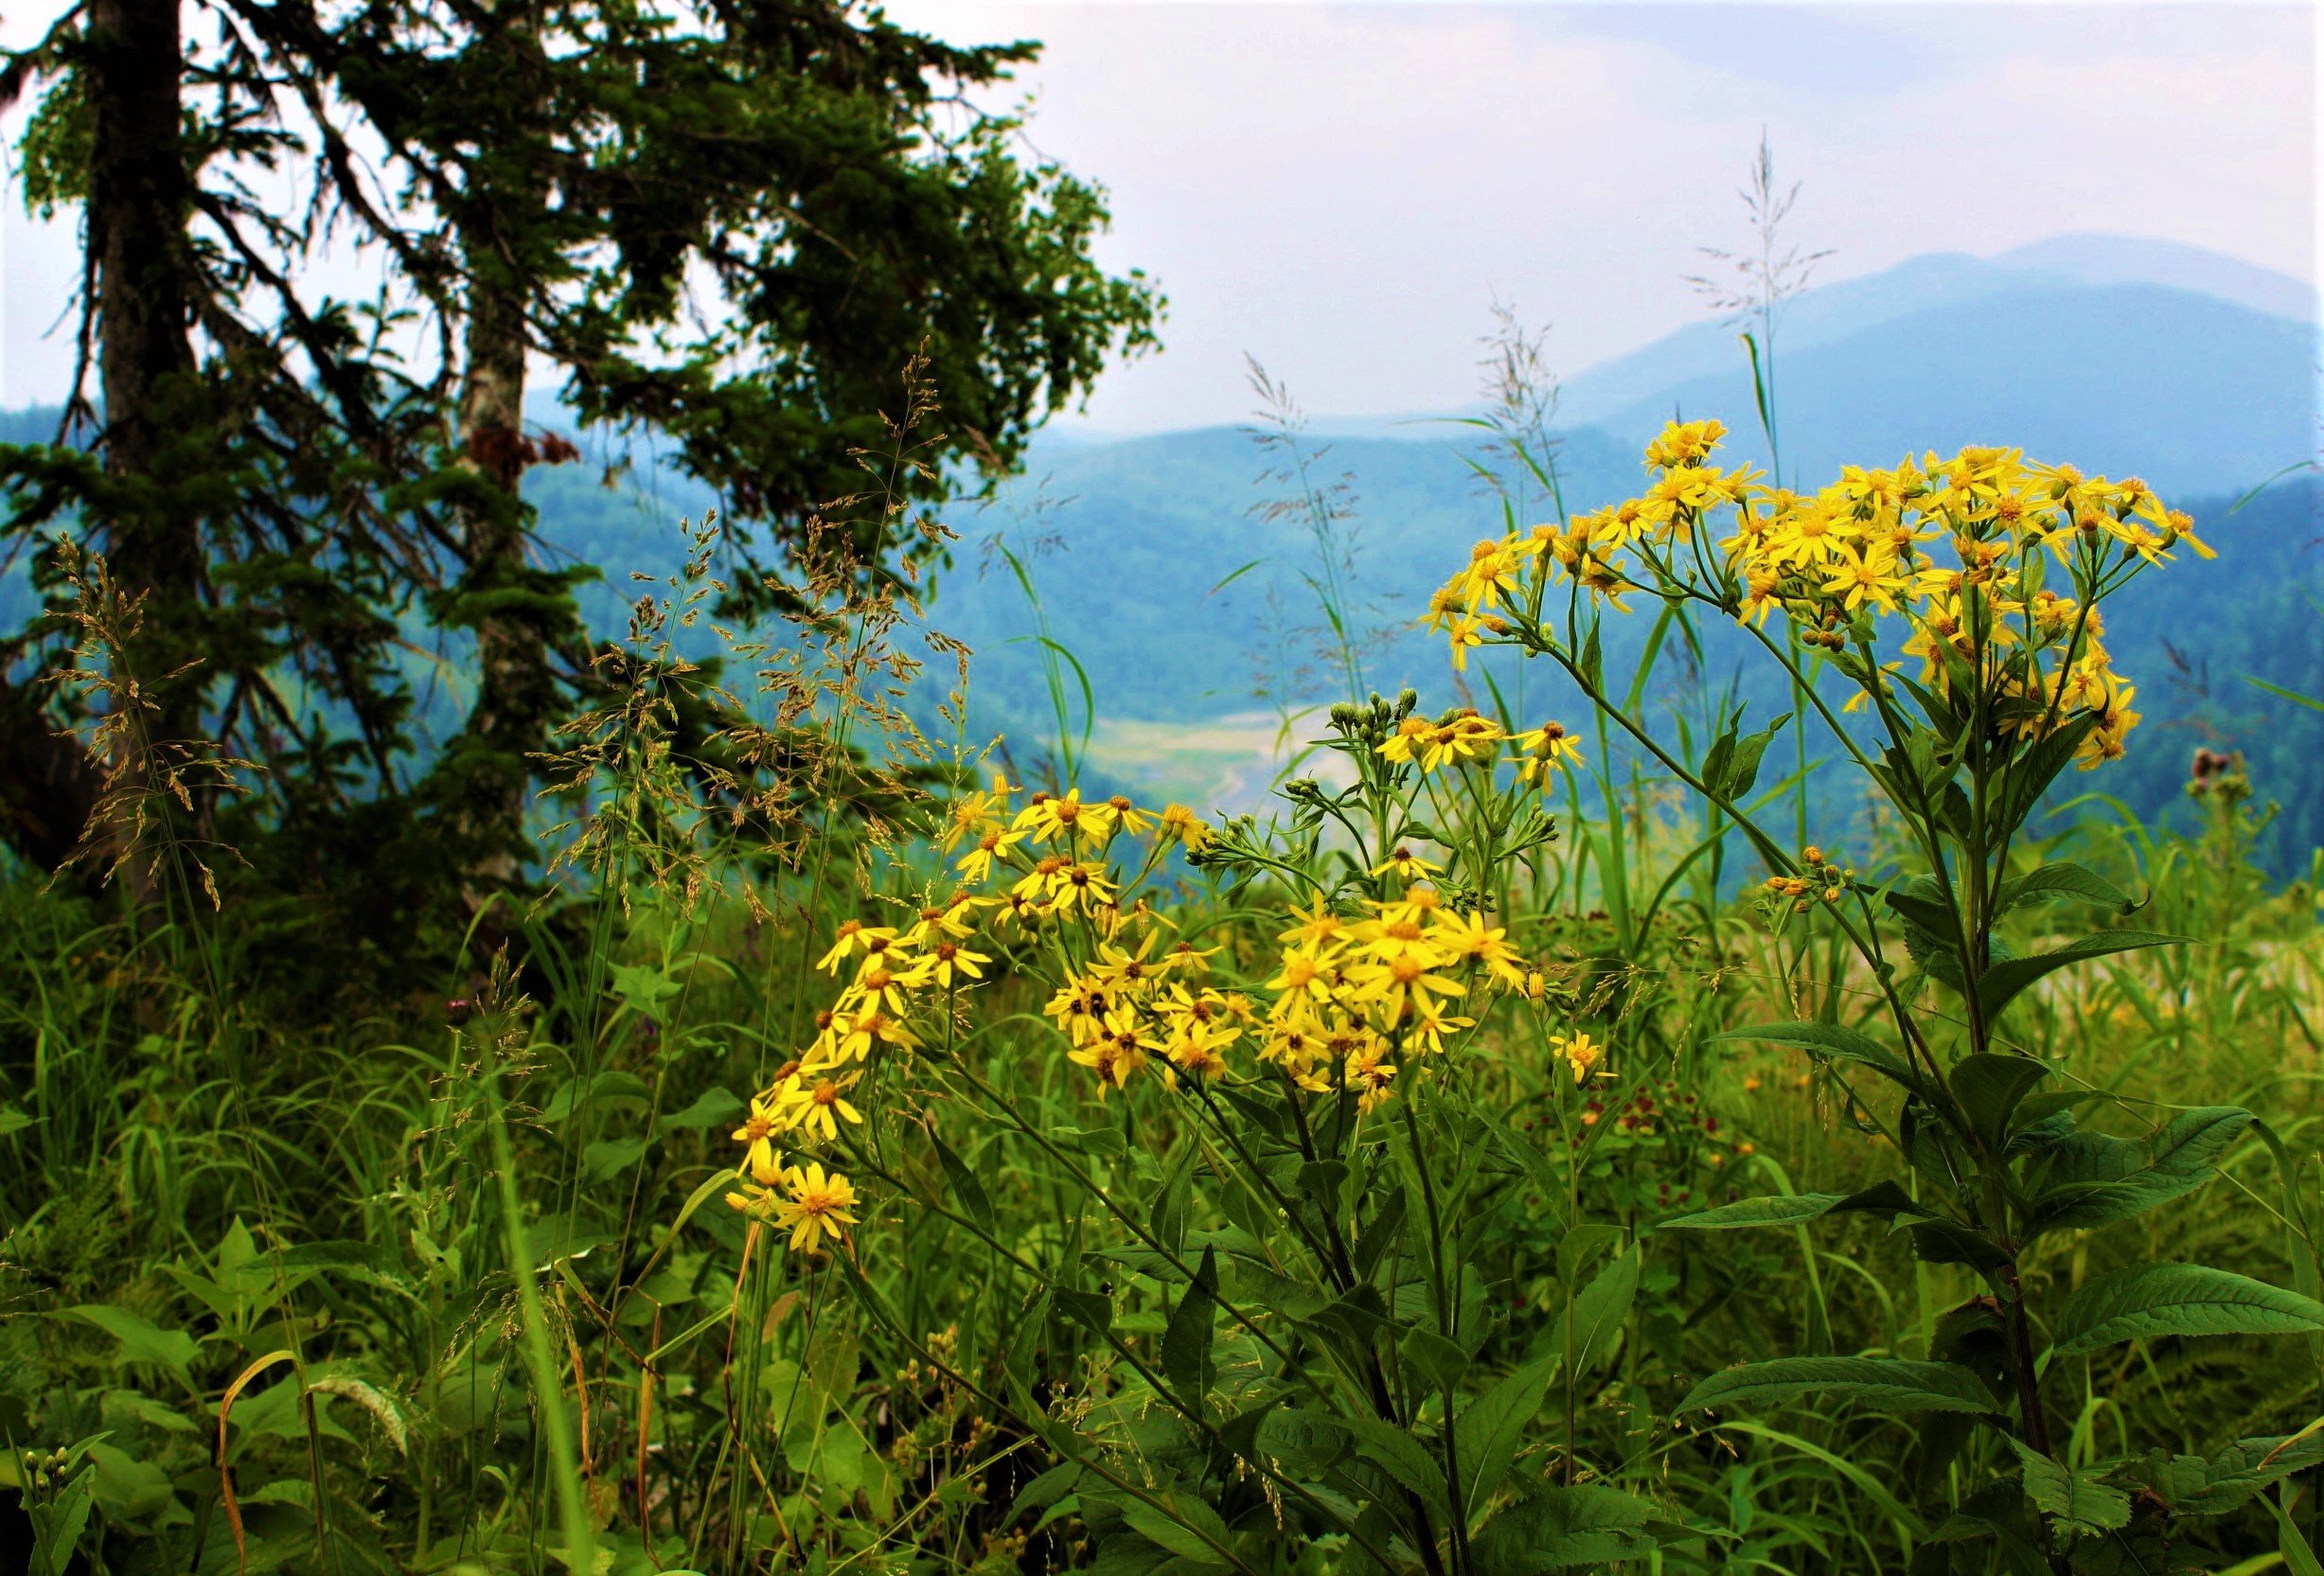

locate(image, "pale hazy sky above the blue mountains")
[[0, 0, 2319, 430]]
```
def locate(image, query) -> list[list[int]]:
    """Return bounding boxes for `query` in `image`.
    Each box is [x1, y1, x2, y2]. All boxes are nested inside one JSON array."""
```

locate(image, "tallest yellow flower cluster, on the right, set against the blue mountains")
[[1425, 420, 2212, 770]]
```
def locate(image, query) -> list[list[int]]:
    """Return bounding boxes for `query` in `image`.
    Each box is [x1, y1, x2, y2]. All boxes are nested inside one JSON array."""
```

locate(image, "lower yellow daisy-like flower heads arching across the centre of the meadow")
[[753, 767, 1604, 1250]]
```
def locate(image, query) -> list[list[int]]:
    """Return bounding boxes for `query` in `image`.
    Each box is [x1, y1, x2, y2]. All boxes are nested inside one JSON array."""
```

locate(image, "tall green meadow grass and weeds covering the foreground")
[[0, 411, 2324, 1576]]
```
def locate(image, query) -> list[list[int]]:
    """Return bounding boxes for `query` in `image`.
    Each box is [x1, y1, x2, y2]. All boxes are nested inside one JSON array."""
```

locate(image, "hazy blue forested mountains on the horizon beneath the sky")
[[0, 237, 2324, 858]]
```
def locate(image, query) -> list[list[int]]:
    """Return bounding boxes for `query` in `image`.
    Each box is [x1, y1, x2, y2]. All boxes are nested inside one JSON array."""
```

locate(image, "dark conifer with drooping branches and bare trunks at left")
[[0, 0, 1160, 901]]
